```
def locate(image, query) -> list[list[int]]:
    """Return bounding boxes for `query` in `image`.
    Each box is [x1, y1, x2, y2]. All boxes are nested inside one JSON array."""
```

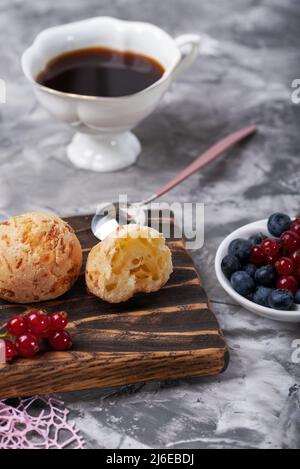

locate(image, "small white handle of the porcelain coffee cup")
[[172, 34, 201, 79]]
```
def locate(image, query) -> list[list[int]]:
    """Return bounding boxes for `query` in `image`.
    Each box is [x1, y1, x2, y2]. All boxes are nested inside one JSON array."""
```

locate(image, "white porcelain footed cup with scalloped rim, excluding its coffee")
[[22, 17, 200, 172]]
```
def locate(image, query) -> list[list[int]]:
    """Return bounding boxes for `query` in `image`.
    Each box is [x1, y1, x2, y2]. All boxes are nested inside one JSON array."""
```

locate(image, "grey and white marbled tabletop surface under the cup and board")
[[0, 0, 300, 448]]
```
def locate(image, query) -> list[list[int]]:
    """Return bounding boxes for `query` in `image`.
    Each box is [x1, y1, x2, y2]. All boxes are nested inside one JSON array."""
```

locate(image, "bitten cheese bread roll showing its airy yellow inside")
[[86, 224, 173, 303]]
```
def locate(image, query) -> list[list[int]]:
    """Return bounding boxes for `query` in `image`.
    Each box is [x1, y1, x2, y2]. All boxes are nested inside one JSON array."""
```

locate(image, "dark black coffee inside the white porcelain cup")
[[36, 47, 165, 98]]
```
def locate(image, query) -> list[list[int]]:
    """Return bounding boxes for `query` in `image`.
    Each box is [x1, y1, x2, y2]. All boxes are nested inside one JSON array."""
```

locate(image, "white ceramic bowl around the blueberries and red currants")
[[215, 220, 300, 323]]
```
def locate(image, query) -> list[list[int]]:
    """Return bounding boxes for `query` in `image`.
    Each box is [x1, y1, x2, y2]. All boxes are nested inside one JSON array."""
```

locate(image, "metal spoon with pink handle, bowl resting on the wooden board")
[[91, 125, 256, 240]]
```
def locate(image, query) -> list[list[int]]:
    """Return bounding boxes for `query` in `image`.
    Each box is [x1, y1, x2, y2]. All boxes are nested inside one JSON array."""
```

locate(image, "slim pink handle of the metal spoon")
[[143, 125, 256, 204]]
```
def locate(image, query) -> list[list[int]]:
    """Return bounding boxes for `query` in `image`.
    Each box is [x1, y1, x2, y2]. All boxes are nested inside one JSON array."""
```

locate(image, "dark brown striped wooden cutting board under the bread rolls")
[[0, 216, 229, 399]]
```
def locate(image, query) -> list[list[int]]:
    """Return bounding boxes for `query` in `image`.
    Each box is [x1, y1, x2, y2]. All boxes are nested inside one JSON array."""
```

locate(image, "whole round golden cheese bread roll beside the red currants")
[[0, 212, 82, 303]]
